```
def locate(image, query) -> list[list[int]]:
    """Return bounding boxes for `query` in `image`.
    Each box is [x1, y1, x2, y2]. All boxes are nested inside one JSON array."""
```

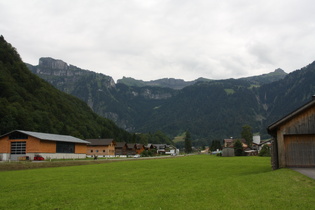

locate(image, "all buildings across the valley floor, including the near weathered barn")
[[0, 96, 315, 169]]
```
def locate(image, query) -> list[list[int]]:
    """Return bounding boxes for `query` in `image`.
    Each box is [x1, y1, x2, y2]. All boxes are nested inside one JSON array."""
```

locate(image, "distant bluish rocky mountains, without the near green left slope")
[[27, 55, 315, 146]]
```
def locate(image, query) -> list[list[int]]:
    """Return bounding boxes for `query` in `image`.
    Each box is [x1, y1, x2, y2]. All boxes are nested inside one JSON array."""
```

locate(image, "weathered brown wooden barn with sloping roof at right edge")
[[267, 96, 315, 169]]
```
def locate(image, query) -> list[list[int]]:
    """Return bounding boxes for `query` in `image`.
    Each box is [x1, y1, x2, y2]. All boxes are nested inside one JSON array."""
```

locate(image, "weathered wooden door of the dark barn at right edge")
[[284, 135, 315, 167]]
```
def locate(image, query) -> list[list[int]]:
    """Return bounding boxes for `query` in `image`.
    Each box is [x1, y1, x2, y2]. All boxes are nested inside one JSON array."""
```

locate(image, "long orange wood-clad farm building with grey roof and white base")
[[0, 130, 89, 160]]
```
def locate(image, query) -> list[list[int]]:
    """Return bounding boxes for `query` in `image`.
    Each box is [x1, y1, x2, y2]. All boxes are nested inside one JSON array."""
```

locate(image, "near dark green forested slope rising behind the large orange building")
[[0, 36, 131, 141]]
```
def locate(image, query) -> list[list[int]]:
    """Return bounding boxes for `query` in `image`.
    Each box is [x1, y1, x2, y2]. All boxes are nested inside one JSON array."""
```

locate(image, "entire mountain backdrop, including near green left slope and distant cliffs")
[[7, 36, 315, 146]]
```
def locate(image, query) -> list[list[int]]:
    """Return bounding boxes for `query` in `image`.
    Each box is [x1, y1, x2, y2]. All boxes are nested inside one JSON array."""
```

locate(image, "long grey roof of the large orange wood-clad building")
[[0, 130, 90, 144]]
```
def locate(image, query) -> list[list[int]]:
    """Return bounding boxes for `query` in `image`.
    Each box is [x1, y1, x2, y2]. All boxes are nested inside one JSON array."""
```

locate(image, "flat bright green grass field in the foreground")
[[0, 155, 315, 210]]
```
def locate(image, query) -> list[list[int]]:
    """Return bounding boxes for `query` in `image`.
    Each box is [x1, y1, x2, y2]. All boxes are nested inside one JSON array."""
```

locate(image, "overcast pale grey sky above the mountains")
[[0, 0, 315, 81]]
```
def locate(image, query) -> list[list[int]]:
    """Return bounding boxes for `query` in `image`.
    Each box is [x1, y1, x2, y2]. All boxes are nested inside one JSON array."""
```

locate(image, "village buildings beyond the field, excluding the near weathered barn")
[[0, 130, 270, 161]]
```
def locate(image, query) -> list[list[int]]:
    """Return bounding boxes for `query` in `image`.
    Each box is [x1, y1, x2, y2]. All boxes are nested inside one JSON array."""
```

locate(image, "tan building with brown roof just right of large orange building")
[[86, 139, 116, 157]]
